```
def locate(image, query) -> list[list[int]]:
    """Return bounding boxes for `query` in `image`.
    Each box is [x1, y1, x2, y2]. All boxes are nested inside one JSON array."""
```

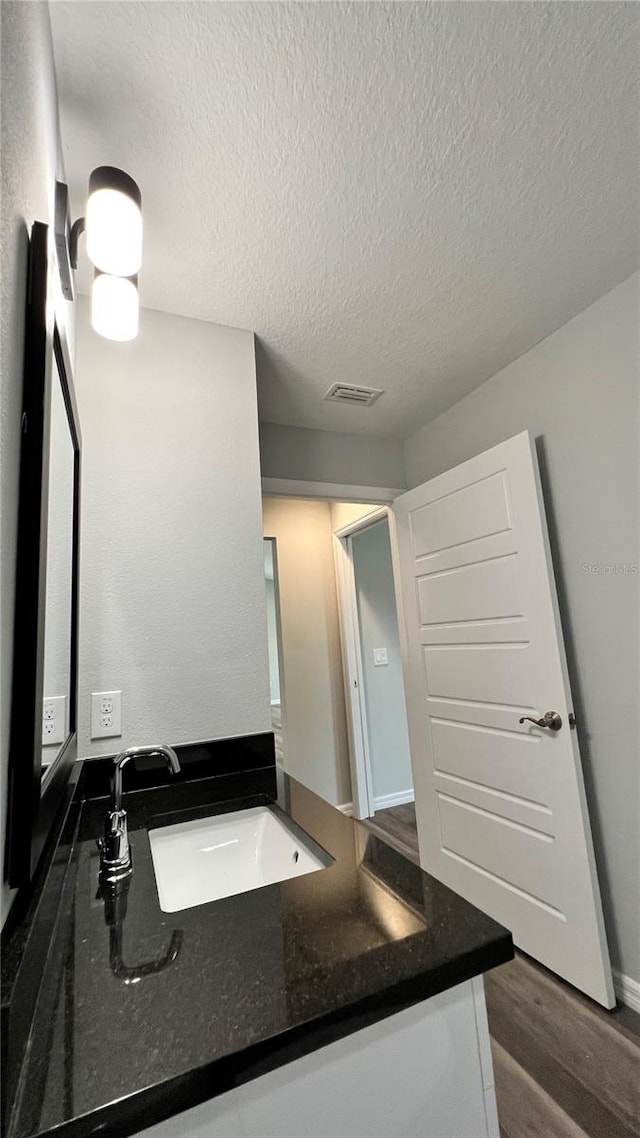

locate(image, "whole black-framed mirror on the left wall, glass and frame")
[[5, 222, 80, 887]]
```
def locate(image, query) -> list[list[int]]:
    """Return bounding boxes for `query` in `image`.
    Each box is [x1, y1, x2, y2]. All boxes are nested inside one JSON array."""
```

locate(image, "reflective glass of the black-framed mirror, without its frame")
[[42, 358, 75, 777]]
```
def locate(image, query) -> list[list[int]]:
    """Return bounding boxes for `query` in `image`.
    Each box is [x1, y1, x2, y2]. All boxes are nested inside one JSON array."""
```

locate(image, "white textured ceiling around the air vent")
[[51, 0, 640, 437]]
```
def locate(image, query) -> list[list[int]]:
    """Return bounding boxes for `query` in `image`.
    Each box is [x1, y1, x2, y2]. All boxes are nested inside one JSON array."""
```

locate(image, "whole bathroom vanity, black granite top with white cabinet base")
[[3, 735, 512, 1138]]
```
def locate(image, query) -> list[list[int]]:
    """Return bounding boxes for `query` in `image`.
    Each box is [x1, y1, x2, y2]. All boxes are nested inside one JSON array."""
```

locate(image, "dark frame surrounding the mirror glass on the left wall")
[[5, 222, 81, 888]]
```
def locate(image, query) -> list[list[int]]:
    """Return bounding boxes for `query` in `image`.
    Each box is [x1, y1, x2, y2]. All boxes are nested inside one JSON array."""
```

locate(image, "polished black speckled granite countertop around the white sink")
[[3, 746, 512, 1138]]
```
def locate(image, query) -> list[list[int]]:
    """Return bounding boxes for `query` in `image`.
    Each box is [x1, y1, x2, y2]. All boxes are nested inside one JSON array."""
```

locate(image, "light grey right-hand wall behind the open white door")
[[405, 274, 640, 981]]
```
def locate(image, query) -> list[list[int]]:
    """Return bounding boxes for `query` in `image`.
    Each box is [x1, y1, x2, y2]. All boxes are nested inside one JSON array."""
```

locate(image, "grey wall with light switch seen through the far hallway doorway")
[[352, 518, 413, 810]]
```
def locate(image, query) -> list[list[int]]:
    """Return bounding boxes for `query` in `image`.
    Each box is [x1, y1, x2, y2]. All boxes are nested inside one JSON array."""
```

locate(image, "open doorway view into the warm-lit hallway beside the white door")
[[263, 495, 416, 832]]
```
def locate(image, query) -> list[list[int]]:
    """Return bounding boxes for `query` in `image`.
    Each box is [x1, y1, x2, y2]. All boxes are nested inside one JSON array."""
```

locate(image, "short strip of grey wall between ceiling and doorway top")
[[260, 423, 407, 487]]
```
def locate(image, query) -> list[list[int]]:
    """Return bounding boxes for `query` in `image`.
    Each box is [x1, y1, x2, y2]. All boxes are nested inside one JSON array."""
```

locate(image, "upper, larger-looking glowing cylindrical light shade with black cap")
[[85, 166, 142, 277]]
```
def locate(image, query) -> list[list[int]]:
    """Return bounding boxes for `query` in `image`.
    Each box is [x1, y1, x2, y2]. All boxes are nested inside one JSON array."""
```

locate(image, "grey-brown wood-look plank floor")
[[367, 806, 640, 1138]]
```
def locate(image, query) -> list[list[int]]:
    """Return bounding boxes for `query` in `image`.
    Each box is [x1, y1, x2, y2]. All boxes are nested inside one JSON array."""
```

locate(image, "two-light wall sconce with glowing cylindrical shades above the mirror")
[[55, 166, 142, 340]]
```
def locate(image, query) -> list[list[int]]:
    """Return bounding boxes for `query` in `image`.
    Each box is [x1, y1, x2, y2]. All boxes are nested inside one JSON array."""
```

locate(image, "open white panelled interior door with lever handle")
[[394, 431, 615, 1007]]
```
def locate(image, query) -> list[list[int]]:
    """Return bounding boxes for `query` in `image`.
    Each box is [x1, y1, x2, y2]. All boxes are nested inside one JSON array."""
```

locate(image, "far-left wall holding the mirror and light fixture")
[[0, 0, 73, 923]]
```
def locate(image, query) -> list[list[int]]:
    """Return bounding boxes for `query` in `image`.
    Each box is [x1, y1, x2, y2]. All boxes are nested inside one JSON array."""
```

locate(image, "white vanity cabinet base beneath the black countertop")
[[141, 976, 499, 1138]]
